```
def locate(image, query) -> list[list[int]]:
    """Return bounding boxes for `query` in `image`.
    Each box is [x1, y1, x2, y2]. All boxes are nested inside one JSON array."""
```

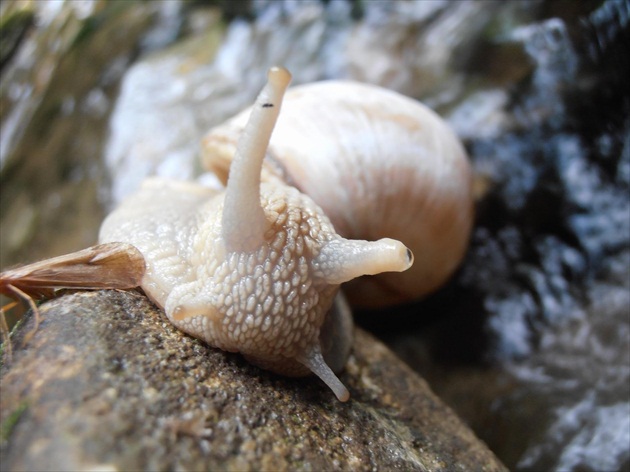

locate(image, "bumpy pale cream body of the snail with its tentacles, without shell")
[[100, 68, 413, 401]]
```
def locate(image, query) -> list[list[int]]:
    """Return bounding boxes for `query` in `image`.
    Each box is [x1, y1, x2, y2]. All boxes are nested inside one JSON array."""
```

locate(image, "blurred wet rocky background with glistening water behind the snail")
[[0, 0, 630, 470]]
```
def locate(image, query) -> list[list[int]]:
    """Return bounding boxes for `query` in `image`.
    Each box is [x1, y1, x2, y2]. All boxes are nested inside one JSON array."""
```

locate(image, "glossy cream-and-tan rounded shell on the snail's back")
[[203, 81, 474, 307]]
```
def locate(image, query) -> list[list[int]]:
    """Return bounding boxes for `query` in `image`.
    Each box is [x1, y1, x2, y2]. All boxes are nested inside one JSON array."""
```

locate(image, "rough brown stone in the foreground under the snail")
[[0, 291, 506, 471]]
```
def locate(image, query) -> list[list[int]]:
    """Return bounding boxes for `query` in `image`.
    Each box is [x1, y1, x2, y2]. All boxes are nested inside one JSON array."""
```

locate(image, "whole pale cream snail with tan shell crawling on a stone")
[[94, 67, 472, 401]]
